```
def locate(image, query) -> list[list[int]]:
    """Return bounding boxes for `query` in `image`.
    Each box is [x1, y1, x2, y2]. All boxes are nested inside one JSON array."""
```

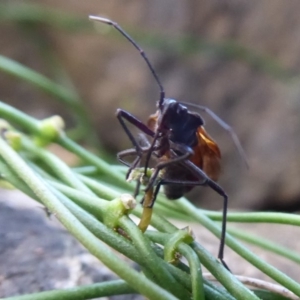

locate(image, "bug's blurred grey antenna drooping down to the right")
[[180, 101, 249, 169]]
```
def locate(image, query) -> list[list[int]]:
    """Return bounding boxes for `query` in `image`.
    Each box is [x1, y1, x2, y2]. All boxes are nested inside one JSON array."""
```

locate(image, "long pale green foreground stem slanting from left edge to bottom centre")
[[0, 138, 175, 299]]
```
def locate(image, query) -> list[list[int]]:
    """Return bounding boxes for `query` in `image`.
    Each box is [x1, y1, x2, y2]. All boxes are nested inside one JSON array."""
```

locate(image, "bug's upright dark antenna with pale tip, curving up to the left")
[[89, 16, 165, 108]]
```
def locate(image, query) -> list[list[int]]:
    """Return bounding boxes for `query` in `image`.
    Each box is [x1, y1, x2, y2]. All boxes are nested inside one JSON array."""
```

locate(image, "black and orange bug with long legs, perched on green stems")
[[90, 16, 247, 269]]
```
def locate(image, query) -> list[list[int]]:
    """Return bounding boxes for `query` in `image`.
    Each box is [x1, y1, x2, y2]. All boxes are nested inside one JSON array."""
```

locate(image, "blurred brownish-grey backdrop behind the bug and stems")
[[0, 0, 300, 211]]
